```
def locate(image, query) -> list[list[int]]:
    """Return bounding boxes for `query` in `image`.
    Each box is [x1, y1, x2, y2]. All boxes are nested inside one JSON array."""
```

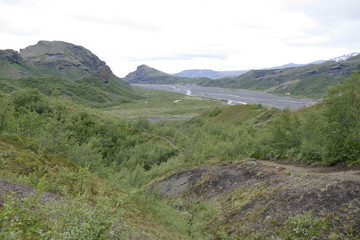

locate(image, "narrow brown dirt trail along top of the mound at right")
[[254, 160, 360, 181]]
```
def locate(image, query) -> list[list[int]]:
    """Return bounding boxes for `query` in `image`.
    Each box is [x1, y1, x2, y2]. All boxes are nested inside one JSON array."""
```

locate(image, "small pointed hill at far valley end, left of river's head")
[[123, 65, 204, 84]]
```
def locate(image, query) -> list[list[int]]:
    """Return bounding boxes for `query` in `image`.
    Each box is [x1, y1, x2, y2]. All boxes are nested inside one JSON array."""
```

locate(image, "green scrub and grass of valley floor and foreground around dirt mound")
[[0, 69, 360, 239]]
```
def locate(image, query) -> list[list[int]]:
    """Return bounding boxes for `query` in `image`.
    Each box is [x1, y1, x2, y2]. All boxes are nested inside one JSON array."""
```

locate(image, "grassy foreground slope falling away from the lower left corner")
[[0, 135, 183, 240]]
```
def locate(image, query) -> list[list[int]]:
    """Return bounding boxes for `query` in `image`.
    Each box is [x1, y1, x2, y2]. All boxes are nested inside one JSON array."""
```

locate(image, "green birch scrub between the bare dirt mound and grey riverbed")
[[150, 73, 360, 165]]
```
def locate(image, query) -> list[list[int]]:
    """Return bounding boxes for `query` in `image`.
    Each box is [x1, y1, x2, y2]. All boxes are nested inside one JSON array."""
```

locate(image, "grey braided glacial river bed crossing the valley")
[[131, 84, 316, 109]]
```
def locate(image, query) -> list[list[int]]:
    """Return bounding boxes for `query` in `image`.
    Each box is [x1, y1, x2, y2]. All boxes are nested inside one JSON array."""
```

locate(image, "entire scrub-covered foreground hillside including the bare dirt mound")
[[0, 68, 360, 240]]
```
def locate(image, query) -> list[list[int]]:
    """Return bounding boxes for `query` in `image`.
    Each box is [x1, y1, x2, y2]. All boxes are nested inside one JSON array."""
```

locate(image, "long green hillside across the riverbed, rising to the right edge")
[[199, 56, 360, 98]]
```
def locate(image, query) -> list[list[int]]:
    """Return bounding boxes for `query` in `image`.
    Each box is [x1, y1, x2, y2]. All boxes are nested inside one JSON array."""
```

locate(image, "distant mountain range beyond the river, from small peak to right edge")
[[123, 53, 360, 98]]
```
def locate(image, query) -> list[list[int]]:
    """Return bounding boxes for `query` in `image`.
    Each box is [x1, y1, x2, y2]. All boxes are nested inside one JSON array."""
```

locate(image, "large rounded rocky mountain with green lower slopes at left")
[[0, 41, 136, 105]]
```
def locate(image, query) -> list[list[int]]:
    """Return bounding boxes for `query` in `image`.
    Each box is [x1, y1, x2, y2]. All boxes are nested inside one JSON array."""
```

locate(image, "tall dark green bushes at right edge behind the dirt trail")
[[324, 72, 360, 164]]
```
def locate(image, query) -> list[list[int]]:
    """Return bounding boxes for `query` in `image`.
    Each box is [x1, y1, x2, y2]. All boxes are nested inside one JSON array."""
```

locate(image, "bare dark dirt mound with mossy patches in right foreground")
[[151, 160, 360, 239]]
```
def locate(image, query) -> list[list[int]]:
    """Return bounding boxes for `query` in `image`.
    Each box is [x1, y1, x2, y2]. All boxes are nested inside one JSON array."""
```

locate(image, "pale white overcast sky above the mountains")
[[0, 0, 360, 77]]
